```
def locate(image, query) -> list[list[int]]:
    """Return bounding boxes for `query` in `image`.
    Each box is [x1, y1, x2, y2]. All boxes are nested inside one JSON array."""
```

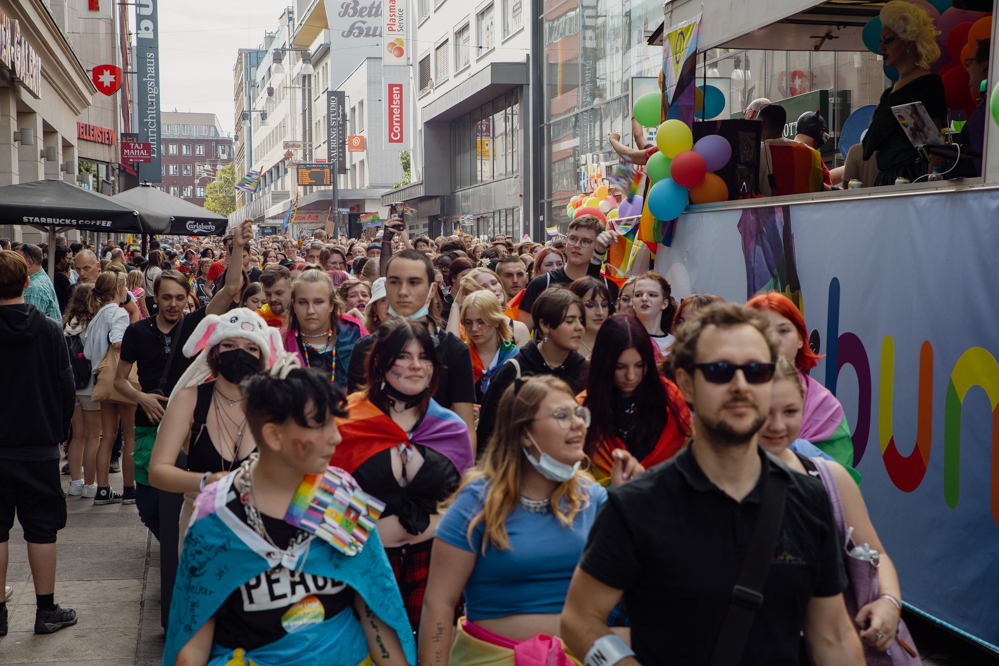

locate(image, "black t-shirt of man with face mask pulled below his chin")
[[347, 320, 475, 409]]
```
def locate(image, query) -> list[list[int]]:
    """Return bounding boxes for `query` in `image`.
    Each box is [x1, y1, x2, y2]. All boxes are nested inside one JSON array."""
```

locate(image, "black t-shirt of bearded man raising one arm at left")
[[121, 308, 207, 428]]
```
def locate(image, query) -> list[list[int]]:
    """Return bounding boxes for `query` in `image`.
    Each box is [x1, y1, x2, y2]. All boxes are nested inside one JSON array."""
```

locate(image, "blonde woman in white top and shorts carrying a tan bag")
[[83, 271, 135, 505]]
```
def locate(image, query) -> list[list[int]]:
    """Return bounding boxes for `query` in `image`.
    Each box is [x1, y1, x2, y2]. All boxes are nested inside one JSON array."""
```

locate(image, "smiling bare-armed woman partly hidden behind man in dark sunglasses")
[[759, 356, 912, 665]]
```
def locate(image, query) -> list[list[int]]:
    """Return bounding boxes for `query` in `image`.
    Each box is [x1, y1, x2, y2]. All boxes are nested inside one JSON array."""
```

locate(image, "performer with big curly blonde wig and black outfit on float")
[[862, 0, 947, 186]]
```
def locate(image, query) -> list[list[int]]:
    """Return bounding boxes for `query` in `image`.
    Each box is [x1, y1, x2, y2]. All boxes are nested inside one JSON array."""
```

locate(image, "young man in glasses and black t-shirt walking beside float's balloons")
[[517, 215, 618, 330]]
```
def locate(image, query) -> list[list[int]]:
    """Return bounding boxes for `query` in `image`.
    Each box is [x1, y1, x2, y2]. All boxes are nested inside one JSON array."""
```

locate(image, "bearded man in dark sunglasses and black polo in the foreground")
[[561, 303, 864, 666]]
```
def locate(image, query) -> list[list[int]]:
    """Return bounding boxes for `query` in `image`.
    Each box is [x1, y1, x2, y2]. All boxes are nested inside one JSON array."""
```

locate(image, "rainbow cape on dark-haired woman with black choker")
[[330, 393, 474, 474]]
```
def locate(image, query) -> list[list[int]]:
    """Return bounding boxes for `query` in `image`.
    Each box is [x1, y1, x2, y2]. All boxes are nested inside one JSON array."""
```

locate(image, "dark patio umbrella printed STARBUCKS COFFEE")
[[0, 180, 170, 278]]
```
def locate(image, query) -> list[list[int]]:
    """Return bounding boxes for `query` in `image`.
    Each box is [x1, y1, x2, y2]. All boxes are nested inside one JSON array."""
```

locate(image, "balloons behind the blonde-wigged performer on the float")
[[863, 0, 992, 116]]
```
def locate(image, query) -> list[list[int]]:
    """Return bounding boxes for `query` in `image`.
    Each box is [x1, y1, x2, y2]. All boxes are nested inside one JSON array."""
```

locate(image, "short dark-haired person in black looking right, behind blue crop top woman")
[[476, 287, 590, 442]]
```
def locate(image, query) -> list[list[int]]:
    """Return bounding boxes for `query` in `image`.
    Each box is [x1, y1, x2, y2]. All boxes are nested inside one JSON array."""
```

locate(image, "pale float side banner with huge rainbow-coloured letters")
[[656, 190, 999, 646]]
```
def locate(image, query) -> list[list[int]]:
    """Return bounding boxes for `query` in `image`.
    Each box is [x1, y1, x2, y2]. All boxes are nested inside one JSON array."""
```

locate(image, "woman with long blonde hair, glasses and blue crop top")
[[419, 375, 612, 666]]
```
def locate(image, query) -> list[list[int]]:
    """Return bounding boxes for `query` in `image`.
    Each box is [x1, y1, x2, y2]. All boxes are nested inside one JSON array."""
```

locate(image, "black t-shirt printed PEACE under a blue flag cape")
[[214, 497, 354, 651]]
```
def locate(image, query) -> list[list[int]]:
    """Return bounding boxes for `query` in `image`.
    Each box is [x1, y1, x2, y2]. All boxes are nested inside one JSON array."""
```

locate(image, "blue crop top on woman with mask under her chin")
[[436, 479, 607, 621]]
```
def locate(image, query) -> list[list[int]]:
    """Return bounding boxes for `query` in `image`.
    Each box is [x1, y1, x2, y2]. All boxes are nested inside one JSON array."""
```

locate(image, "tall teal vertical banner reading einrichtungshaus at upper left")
[[135, 0, 163, 183]]
